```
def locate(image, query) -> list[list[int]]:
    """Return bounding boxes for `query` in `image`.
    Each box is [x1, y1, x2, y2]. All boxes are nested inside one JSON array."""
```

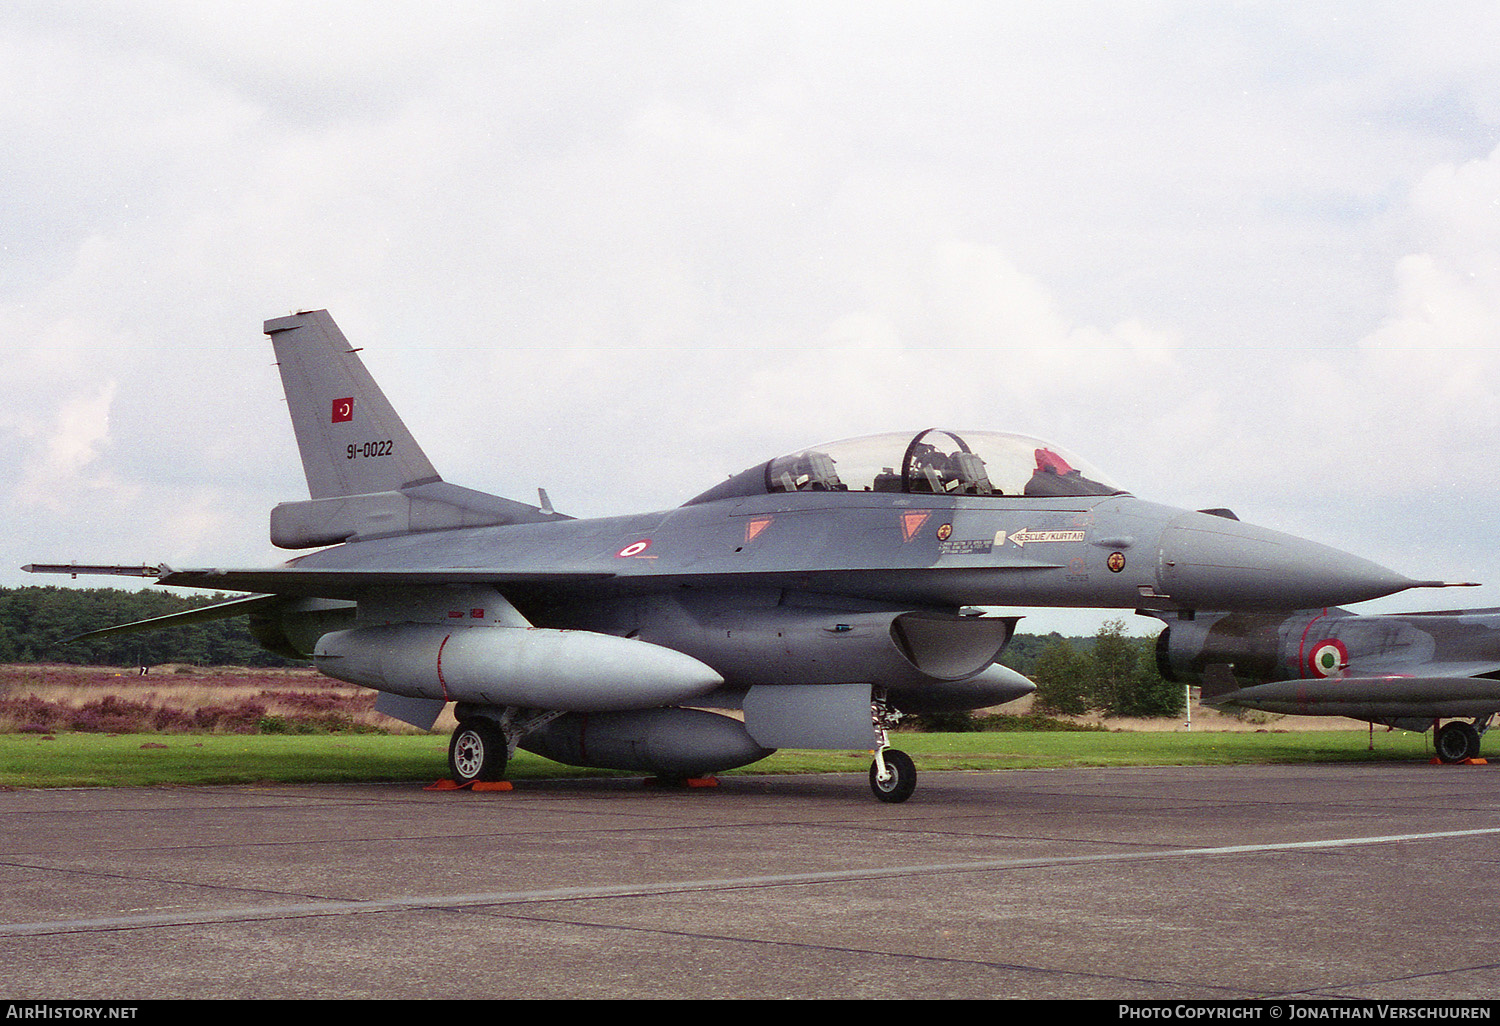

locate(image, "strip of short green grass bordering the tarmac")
[[0, 720, 1431, 788]]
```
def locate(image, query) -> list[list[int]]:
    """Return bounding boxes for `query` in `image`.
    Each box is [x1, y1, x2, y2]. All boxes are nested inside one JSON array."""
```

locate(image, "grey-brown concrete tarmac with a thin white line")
[[0, 764, 1500, 1001]]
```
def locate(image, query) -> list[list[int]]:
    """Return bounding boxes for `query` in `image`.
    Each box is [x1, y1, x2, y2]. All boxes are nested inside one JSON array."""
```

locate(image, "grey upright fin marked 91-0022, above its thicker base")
[[266, 311, 441, 500]]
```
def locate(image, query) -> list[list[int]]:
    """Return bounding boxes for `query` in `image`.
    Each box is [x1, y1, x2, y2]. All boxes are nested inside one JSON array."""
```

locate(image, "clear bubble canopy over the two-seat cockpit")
[[693, 428, 1124, 503]]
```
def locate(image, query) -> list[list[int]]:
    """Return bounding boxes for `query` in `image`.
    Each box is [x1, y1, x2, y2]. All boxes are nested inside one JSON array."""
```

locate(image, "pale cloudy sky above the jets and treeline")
[[0, 0, 1500, 632]]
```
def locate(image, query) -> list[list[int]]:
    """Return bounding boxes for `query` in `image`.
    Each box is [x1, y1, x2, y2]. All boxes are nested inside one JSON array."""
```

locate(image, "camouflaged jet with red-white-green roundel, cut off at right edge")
[[1157, 609, 1500, 762]]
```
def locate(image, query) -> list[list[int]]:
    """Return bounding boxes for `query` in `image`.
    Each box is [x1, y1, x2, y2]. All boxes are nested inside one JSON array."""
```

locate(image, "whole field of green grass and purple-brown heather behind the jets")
[[0, 665, 1452, 788]]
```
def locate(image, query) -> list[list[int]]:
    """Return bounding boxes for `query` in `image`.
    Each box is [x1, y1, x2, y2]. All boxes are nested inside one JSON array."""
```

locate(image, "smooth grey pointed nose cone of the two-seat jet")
[[1157, 513, 1422, 609]]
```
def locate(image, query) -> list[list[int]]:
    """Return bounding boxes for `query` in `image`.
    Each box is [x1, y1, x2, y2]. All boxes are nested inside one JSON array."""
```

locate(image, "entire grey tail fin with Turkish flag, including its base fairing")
[[266, 311, 558, 549]]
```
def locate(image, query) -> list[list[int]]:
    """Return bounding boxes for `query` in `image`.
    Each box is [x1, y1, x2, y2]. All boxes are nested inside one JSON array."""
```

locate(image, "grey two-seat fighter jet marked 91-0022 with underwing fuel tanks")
[[17, 311, 1458, 803]]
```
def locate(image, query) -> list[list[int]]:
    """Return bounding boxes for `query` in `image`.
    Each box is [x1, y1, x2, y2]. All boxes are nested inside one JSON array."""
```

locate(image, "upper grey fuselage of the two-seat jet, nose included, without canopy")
[[240, 492, 1416, 626]]
